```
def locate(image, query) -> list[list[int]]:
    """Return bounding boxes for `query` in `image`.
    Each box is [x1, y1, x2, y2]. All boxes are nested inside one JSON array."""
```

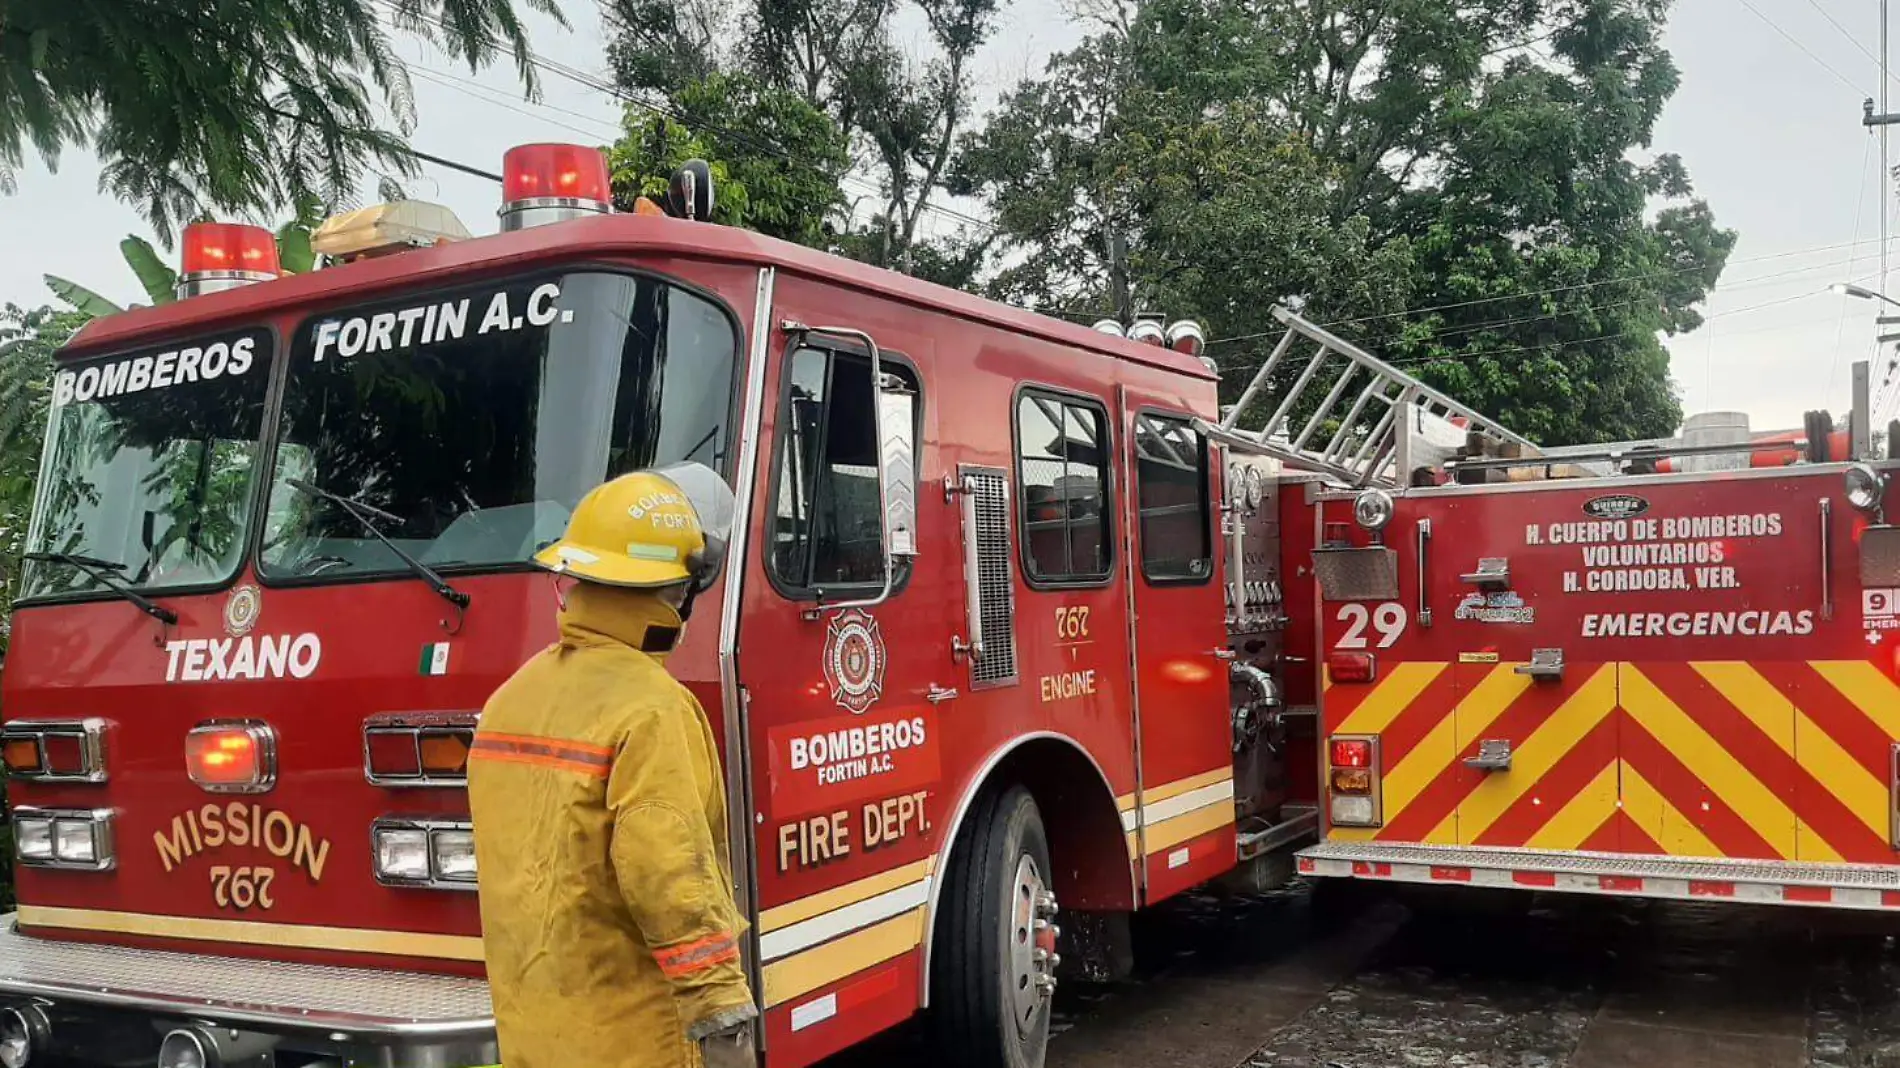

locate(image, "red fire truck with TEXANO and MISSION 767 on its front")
[[0, 144, 1321, 1068]]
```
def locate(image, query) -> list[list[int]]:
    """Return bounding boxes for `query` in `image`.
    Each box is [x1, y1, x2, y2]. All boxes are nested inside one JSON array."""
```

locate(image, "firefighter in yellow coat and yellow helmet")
[[469, 464, 758, 1068]]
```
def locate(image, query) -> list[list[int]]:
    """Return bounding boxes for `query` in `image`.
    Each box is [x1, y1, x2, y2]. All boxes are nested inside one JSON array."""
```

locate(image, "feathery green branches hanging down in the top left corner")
[[0, 0, 561, 243]]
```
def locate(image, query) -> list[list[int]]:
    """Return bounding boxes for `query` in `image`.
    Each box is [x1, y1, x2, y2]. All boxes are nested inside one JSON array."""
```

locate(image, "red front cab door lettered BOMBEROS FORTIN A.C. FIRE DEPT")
[[733, 324, 960, 1064]]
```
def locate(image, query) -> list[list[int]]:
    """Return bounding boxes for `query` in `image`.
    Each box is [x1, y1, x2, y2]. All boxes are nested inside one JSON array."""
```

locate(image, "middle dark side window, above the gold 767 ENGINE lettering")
[[1017, 390, 1115, 585]]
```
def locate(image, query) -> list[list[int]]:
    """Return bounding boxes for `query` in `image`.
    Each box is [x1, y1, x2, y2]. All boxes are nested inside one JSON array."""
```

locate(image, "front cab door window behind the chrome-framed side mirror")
[[768, 348, 918, 597]]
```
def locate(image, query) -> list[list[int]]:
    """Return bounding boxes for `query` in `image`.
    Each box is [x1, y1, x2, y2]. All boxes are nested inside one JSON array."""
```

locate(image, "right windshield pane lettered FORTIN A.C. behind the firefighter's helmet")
[[260, 272, 739, 580]]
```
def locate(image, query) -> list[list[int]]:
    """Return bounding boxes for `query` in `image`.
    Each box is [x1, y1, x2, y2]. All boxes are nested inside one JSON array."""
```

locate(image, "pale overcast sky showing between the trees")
[[0, 0, 1900, 428]]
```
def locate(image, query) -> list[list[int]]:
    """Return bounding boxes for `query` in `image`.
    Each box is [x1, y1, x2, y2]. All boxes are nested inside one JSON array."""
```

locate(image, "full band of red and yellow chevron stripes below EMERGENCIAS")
[[1324, 661, 1900, 863]]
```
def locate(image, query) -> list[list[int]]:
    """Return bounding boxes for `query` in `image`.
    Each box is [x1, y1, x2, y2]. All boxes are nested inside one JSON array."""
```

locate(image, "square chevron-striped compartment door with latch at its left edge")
[[1435, 658, 1617, 849]]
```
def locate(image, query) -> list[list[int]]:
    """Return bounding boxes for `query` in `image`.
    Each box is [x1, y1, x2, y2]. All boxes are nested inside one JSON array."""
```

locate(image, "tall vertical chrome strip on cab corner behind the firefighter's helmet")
[[718, 268, 777, 1026]]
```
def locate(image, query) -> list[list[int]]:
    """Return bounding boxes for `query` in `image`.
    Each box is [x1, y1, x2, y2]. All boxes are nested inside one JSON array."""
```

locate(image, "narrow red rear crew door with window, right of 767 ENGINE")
[[1119, 386, 1235, 901]]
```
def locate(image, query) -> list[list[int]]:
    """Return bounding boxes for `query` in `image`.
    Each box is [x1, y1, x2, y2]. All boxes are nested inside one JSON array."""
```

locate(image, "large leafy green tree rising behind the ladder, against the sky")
[[952, 0, 1735, 443]]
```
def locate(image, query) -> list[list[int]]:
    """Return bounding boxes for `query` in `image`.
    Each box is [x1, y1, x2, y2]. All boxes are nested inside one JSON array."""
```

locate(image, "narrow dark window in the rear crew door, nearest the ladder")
[[1134, 412, 1214, 582]]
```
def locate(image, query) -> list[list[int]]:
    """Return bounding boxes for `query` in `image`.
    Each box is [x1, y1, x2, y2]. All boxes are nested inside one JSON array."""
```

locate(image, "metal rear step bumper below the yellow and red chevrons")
[[1298, 842, 1900, 912]]
